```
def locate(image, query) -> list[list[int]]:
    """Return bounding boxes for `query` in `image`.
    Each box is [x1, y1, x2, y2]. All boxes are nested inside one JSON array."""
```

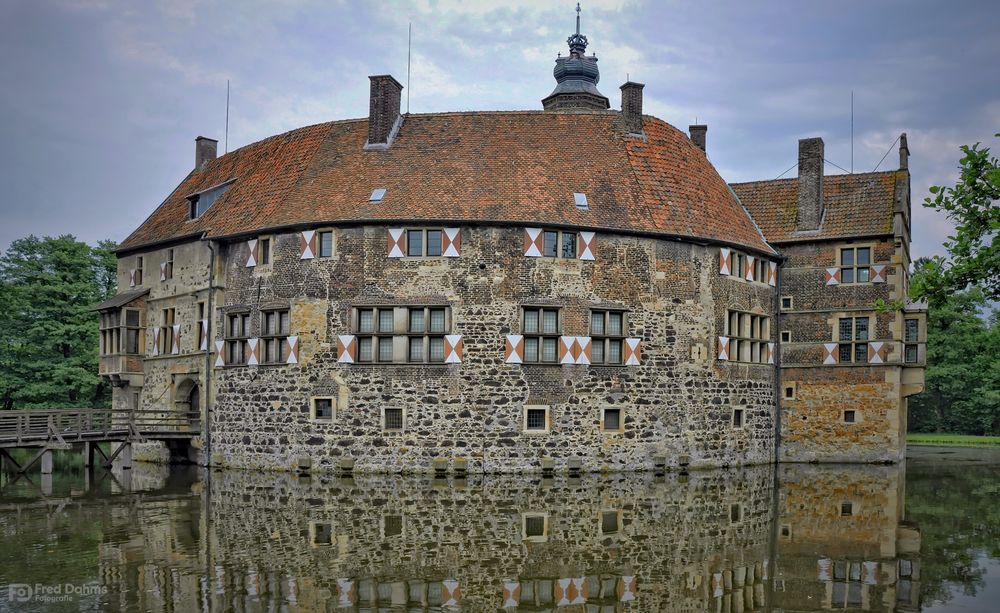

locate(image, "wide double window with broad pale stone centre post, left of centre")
[[355, 306, 450, 364]]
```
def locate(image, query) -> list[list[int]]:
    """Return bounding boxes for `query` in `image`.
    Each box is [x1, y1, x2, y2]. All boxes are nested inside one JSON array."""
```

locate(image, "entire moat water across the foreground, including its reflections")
[[0, 447, 1000, 613]]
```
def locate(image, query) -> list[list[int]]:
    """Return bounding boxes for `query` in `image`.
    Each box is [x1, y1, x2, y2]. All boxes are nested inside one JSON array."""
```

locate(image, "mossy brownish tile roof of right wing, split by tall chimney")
[[732, 171, 906, 243]]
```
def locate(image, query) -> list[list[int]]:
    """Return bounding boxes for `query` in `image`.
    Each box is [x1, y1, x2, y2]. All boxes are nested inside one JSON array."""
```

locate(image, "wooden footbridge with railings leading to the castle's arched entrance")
[[0, 409, 201, 474]]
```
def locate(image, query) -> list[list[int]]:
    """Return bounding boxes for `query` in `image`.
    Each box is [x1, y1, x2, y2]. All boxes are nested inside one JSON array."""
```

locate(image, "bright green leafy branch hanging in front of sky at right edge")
[[912, 134, 1000, 300]]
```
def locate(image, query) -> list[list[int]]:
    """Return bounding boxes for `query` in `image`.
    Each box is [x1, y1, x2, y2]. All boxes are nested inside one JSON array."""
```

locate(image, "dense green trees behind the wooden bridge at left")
[[0, 235, 117, 409]]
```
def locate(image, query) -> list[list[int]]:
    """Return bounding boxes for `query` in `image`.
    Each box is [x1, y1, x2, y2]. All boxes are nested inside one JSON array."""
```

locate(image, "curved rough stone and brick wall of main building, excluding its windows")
[[212, 226, 775, 472]]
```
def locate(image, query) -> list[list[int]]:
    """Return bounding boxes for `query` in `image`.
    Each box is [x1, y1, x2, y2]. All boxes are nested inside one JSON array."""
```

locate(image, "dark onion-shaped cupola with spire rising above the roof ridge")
[[542, 3, 611, 111]]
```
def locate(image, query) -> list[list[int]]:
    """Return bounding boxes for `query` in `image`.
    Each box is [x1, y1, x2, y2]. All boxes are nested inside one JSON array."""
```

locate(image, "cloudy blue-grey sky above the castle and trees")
[[0, 0, 1000, 256]]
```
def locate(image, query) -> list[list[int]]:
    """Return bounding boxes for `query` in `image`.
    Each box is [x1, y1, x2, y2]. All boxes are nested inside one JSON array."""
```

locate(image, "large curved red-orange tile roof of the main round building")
[[120, 111, 773, 253]]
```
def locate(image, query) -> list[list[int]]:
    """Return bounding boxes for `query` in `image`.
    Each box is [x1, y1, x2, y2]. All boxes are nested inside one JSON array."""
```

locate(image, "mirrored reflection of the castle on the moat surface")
[[82, 465, 919, 613]]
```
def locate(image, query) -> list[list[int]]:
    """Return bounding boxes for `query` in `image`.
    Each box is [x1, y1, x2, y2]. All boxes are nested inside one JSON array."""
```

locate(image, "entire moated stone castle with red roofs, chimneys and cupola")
[[99, 10, 925, 472]]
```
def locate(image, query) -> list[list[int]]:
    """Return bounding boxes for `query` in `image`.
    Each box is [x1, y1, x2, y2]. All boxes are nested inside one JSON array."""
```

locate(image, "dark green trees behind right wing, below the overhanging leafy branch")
[[909, 259, 1000, 435]]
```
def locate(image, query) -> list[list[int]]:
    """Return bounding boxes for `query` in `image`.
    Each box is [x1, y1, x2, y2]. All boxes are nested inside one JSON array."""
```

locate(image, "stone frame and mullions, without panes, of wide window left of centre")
[[350, 304, 454, 365]]
